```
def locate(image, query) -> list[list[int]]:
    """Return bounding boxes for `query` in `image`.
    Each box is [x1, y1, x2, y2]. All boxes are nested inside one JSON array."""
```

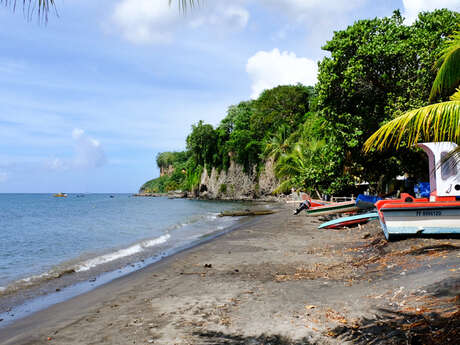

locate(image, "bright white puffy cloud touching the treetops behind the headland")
[[246, 48, 318, 98]]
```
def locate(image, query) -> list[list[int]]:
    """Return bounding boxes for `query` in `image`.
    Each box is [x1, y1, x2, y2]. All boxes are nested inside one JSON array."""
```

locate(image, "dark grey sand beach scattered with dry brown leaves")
[[0, 205, 460, 345]]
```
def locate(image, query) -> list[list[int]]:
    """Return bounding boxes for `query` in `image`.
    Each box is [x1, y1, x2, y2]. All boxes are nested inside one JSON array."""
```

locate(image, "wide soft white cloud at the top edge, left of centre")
[[111, 0, 249, 44]]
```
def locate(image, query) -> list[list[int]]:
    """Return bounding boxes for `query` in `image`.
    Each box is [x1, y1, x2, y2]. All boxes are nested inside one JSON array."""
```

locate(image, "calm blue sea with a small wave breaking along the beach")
[[0, 194, 258, 327]]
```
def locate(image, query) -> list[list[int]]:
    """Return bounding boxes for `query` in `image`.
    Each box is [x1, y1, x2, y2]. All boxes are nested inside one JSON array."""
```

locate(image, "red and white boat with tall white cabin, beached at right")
[[375, 142, 460, 241]]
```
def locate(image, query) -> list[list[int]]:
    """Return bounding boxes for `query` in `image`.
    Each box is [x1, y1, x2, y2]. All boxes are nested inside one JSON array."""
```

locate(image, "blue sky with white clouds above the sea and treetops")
[[0, 0, 460, 193]]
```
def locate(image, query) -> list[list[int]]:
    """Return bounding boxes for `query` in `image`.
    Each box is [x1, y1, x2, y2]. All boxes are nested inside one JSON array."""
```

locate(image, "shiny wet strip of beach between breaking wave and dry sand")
[[0, 203, 275, 331]]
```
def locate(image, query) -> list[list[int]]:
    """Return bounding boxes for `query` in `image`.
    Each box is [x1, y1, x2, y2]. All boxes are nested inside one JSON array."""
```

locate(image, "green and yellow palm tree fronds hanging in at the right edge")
[[364, 32, 460, 159]]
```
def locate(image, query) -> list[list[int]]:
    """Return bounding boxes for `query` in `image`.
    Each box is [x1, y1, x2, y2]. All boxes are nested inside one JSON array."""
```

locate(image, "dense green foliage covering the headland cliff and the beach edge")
[[142, 10, 460, 193]]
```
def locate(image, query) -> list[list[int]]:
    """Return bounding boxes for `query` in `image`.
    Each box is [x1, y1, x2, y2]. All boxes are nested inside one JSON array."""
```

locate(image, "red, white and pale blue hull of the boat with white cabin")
[[378, 203, 460, 240]]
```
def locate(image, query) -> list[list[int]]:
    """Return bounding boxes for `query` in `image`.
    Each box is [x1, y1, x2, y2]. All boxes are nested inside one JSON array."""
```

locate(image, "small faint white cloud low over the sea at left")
[[46, 128, 107, 171]]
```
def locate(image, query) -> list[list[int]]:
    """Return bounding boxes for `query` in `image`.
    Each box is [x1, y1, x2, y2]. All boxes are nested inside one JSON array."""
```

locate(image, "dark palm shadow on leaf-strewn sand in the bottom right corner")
[[331, 276, 460, 345]]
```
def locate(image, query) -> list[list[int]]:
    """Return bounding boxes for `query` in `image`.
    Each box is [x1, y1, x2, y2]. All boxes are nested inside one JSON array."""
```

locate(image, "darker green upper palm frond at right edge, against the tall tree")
[[430, 32, 460, 102]]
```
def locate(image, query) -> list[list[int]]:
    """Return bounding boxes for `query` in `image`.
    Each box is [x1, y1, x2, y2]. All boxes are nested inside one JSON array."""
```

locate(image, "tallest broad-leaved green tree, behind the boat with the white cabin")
[[317, 10, 460, 189]]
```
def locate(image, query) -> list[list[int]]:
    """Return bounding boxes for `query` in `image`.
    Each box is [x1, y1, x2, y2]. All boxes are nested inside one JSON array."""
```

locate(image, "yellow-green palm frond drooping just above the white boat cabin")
[[364, 100, 460, 152]]
